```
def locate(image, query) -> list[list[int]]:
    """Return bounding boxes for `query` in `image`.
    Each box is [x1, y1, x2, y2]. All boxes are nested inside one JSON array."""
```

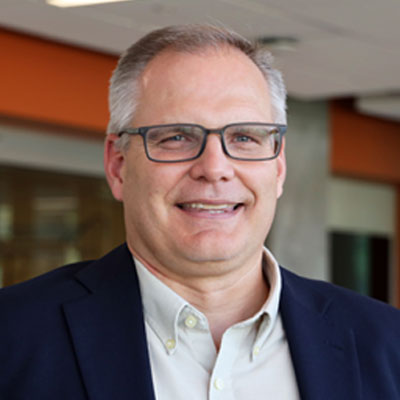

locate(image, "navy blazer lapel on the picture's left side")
[[64, 246, 154, 400]]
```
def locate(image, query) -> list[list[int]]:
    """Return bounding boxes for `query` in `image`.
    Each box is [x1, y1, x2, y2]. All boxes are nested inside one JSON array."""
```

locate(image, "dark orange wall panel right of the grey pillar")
[[330, 102, 400, 183]]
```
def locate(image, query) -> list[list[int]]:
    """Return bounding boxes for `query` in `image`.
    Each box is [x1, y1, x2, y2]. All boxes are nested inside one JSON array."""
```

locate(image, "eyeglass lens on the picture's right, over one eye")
[[224, 124, 280, 159]]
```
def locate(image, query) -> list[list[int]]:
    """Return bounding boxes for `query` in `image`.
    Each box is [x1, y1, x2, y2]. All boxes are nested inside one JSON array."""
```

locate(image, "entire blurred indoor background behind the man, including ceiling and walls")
[[0, 0, 400, 307]]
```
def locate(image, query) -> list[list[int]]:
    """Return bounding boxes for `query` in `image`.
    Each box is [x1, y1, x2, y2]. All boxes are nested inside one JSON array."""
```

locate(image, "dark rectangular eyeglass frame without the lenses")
[[118, 122, 287, 163]]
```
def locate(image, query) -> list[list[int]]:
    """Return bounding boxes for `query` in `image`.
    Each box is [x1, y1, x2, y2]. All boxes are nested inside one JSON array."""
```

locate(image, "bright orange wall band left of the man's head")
[[0, 29, 117, 132]]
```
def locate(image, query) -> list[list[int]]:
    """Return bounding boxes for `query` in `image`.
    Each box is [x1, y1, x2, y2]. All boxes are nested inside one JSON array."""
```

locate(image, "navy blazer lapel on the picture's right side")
[[280, 270, 361, 400]]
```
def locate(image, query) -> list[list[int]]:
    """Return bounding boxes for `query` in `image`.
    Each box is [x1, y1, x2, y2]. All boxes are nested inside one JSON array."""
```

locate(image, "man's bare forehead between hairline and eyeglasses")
[[135, 47, 271, 124]]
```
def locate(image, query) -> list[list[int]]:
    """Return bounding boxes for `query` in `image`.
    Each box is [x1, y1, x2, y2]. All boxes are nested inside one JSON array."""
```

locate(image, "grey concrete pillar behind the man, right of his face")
[[267, 100, 329, 280]]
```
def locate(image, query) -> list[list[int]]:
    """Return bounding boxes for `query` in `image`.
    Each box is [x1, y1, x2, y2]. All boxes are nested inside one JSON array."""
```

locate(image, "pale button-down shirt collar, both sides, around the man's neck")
[[133, 248, 282, 356]]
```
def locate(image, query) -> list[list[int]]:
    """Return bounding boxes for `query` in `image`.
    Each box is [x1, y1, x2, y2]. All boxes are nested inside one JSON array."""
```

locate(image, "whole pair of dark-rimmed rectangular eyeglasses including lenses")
[[118, 122, 286, 163]]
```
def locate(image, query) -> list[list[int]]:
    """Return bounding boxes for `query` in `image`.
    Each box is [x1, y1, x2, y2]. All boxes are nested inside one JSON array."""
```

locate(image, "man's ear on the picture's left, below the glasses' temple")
[[104, 134, 125, 201]]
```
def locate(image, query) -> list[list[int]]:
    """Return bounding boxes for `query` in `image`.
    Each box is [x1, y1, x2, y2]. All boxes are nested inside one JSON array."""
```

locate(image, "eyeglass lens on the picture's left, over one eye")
[[146, 125, 204, 161]]
